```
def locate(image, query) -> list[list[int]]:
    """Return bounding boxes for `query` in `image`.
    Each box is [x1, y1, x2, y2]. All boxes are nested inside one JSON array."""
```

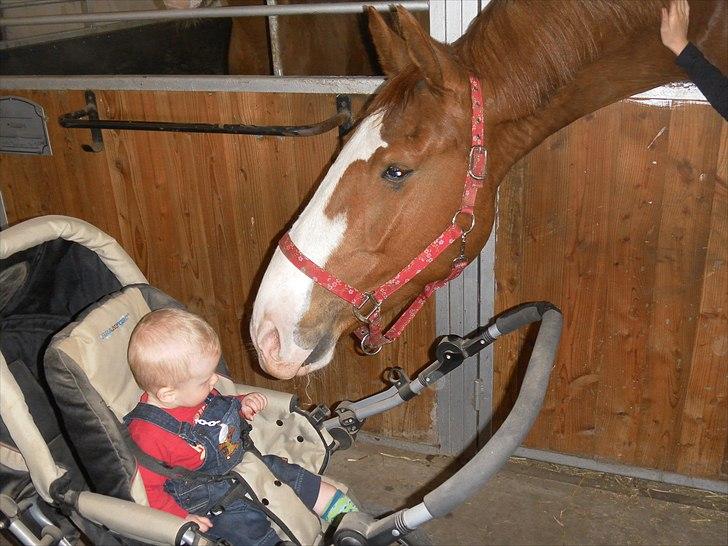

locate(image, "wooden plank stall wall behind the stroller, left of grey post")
[[0, 91, 435, 443]]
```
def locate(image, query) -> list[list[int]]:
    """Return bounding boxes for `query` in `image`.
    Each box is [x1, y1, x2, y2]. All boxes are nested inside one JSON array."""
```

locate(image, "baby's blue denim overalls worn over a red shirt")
[[124, 394, 321, 546]]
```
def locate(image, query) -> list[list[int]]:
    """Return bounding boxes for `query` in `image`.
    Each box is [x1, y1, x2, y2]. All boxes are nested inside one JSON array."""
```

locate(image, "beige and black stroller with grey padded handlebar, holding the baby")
[[0, 216, 562, 546]]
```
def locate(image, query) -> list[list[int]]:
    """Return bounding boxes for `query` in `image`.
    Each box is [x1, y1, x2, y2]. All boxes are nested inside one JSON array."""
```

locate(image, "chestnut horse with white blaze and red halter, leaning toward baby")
[[250, 0, 728, 379]]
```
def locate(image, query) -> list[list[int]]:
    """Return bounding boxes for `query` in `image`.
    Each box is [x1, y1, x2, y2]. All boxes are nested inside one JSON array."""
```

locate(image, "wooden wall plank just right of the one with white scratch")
[[636, 104, 726, 470]]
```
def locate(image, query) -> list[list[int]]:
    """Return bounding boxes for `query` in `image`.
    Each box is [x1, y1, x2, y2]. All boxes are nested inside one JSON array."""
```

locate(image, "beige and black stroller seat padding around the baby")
[[45, 284, 334, 544]]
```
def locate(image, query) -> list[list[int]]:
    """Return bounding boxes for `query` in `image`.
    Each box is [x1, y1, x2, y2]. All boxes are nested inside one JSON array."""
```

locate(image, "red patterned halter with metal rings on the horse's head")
[[278, 76, 487, 355]]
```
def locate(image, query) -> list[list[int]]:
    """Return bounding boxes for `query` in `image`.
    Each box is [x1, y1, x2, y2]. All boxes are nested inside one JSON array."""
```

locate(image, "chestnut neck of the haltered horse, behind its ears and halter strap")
[[453, 0, 708, 184]]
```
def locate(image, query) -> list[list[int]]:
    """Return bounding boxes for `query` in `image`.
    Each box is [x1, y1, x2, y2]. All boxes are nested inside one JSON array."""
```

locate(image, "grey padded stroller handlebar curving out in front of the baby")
[[324, 302, 563, 546]]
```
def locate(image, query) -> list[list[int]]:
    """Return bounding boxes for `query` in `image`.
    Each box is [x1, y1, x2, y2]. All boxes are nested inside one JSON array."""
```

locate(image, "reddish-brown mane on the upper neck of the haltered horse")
[[453, 0, 666, 110]]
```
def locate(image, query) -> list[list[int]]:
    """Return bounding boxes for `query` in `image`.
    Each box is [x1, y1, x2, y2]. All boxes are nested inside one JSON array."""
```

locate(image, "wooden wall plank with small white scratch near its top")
[[594, 102, 670, 463]]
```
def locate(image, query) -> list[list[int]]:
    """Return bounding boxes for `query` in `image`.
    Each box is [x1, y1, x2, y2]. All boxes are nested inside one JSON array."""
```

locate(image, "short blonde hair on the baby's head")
[[127, 309, 220, 393]]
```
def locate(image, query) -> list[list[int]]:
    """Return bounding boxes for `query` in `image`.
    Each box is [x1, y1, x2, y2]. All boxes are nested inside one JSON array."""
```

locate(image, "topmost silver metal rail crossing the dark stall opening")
[[0, 0, 429, 26]]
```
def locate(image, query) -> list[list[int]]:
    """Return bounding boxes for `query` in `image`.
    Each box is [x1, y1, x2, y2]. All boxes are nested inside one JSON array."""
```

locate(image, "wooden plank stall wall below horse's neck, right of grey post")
[[494, 101, 728, 480]]
